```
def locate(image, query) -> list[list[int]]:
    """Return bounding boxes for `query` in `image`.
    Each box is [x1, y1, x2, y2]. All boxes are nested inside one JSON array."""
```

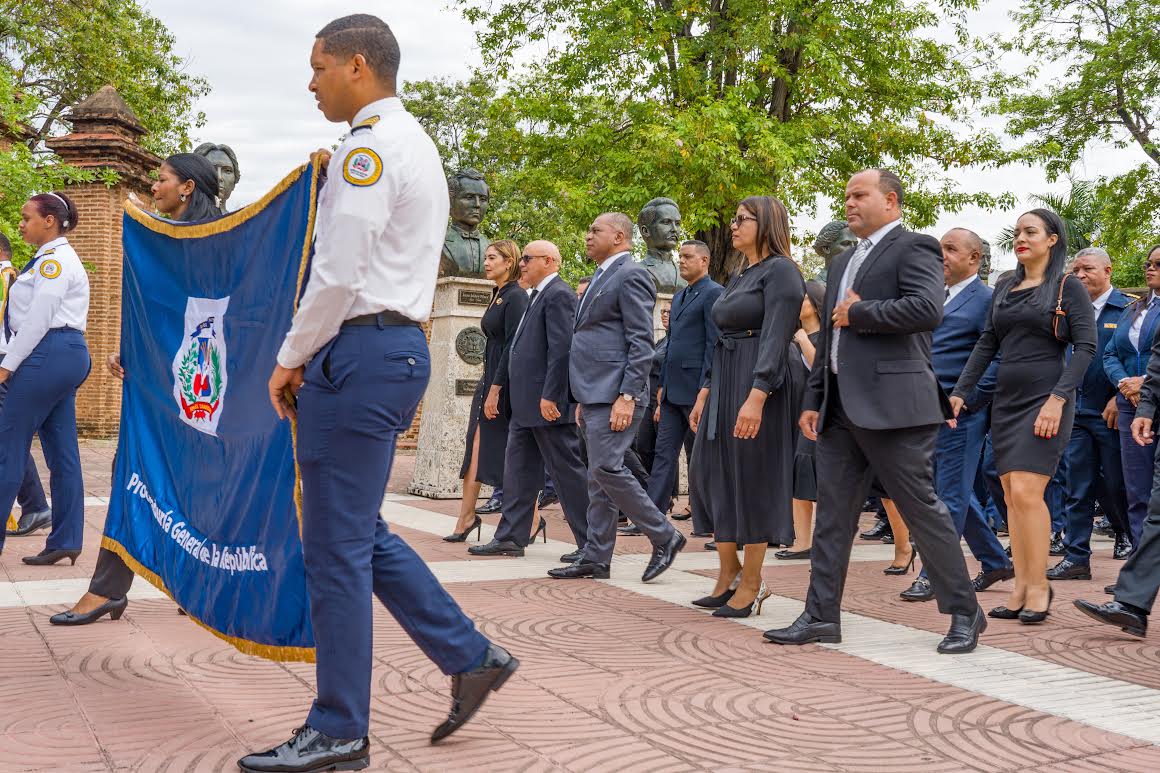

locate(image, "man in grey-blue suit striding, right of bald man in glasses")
[[548, 212, 684, 581]]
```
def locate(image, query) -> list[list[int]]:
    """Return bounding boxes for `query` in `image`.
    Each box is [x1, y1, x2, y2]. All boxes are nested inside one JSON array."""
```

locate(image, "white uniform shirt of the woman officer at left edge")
[[0, 237, 88, 370]]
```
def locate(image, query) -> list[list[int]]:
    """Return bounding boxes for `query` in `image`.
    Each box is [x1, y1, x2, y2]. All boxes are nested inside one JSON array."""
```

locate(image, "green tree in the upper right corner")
[[993, 0, 1160, 283]]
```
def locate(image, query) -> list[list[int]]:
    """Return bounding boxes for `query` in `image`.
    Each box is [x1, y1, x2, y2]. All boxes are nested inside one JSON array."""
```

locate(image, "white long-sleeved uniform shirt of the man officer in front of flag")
[[278, 97, 451, 368]]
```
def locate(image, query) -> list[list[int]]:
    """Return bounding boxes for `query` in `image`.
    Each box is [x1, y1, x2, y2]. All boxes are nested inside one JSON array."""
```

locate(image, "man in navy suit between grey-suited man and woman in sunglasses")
[[648, 240, 725, 534]]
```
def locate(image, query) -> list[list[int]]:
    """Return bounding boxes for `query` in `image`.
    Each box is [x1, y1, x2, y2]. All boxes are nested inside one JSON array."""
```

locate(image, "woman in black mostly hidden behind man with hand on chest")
[[774, 280, 826, 561]]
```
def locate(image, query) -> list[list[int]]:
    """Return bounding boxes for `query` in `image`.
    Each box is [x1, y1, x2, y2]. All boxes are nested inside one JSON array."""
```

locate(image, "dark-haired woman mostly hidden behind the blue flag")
[[49, 153, 223, 626]]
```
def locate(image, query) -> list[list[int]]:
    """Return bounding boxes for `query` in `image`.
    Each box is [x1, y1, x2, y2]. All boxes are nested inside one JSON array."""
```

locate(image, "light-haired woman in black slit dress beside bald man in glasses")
[[443, 239, 531, 542]]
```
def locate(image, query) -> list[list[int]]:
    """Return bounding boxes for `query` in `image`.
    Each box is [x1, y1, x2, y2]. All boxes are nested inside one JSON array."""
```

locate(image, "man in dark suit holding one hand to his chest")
[[766, 169, 986, 653]]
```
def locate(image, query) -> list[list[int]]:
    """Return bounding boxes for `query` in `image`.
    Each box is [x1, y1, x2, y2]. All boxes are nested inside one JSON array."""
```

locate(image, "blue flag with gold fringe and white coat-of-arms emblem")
[[102, 165, 319, 660]]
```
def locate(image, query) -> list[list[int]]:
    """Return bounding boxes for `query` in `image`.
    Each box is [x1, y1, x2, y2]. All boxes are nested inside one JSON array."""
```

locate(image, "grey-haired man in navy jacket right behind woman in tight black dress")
[[1047, 247, 1136, 580]]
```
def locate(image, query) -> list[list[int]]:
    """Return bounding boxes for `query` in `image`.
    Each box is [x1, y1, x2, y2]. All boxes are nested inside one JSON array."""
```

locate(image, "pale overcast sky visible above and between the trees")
[[144, 0, 1144, 268]]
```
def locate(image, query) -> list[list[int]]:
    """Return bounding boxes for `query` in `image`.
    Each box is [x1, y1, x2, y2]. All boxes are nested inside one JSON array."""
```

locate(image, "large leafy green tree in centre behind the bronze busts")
[[436, 0, 1012, 276]]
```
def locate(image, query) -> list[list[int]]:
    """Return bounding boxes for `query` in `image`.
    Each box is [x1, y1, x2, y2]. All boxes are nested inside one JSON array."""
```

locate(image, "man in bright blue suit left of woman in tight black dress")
[[900, 229, 1015, 601]]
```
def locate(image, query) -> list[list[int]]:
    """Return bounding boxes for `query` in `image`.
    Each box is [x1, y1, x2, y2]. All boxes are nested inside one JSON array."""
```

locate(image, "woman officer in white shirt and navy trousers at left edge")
[[0, 193, 90, 565]]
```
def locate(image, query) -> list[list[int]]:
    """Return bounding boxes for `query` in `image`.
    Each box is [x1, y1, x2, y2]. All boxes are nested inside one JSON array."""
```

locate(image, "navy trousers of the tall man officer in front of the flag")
[[298, 325, 488, 738]]
